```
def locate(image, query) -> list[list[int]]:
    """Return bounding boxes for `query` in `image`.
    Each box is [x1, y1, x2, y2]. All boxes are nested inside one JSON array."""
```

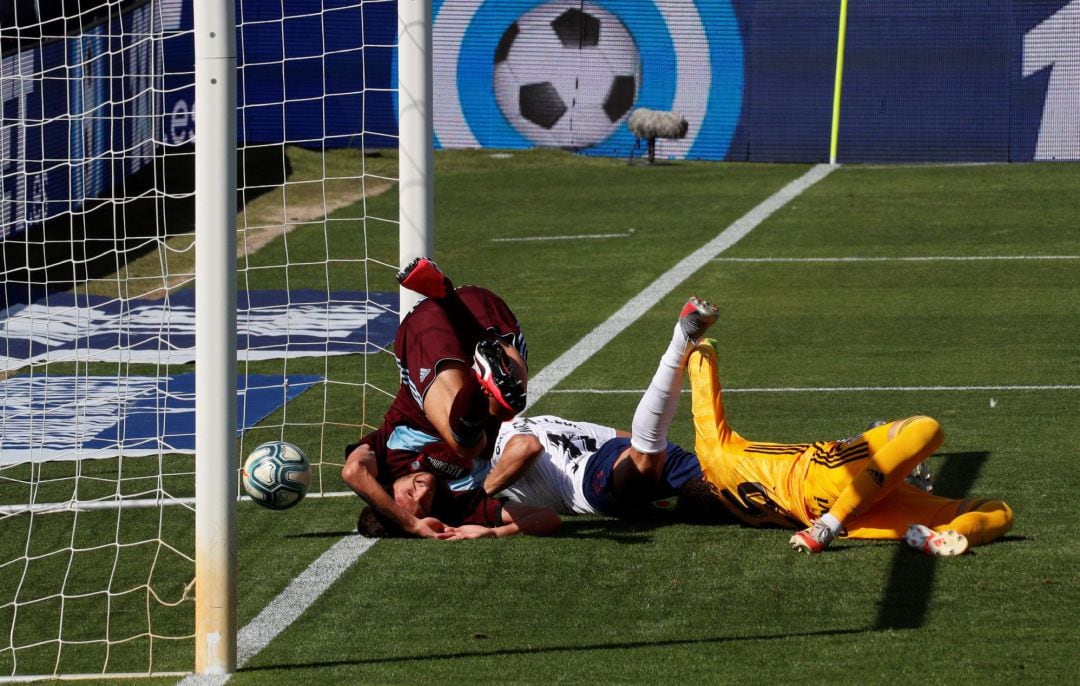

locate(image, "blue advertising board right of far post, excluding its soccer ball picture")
[[434, 0, 1080, 162]]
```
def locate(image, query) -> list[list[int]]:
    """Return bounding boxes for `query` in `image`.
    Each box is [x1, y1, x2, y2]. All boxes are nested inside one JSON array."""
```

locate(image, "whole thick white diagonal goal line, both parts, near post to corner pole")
[[180, 164, 834, 686]]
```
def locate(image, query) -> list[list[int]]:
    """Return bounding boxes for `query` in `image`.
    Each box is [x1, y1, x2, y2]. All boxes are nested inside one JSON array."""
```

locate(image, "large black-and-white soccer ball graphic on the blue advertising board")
[[495, 0, 642, 149]]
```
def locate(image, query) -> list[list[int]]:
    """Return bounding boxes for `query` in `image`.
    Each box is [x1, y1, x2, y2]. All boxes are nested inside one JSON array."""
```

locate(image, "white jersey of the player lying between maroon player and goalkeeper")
[[491, 415, 616, 514]]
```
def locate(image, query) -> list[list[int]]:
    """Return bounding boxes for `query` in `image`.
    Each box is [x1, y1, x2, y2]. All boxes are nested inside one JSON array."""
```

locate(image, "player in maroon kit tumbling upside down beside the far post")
[[342, 258, 528, 537]]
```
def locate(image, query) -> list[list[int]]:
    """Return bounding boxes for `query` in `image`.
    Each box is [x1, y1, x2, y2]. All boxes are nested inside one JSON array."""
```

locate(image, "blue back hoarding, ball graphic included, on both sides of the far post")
[[143, 0, 1080, 162]]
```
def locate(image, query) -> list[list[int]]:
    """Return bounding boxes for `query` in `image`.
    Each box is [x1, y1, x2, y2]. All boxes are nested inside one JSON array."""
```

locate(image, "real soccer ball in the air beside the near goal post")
[[241, 441, 311, 510]]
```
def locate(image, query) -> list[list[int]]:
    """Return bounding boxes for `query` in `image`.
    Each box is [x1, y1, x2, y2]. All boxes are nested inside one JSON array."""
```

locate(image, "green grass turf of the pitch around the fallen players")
[[0, 151, 1080, 684]]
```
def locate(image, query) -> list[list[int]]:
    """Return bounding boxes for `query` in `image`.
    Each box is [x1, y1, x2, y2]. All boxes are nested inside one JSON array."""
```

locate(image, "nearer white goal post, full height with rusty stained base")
[[194, 0, 237, 674]]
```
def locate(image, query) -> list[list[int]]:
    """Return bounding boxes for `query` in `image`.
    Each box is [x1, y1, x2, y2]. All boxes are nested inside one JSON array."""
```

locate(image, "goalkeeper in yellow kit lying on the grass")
[[688, 339, 1013, 555]]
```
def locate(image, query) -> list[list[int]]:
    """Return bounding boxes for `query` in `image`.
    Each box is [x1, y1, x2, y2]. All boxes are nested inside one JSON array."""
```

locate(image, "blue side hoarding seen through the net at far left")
[[0, 2, 191, 238]]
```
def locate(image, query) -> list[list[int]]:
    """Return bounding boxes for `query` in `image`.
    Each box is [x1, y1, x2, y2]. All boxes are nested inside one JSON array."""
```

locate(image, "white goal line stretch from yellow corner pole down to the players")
[[526, 164, 834, 409]]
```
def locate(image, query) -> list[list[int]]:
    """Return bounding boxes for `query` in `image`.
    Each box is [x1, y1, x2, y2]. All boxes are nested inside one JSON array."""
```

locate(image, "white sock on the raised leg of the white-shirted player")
[[630, 323, 687, 454]]
